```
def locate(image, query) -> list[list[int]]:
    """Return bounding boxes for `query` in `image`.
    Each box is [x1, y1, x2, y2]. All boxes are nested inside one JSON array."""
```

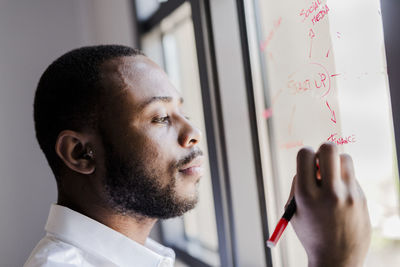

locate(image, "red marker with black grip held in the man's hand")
[[267, 158, 321, 248]]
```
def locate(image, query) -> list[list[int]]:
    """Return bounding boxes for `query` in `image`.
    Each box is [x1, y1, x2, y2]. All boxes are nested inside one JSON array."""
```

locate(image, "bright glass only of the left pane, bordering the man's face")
[[142, 3, 219, 266]]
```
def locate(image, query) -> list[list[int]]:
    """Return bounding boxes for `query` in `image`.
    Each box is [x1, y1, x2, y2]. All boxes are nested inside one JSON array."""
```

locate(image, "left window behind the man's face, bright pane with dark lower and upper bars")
[[137, 1, 221, 266]]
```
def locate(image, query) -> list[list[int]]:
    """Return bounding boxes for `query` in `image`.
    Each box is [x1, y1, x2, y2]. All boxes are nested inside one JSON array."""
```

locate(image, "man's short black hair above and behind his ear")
[[33, 45, 144, 180]]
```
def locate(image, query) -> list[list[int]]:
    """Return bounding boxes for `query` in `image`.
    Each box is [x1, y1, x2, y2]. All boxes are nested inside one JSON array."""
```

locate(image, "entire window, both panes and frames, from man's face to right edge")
[[135, 0, 400, 267]]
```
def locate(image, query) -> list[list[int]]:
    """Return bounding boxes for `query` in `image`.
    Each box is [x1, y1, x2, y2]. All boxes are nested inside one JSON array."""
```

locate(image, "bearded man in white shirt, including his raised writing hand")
[[25, 45, 370, 267]]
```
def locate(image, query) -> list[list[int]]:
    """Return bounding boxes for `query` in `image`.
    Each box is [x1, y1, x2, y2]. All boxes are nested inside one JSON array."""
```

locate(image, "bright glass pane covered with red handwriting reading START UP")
[[246, 0, 400, 266]]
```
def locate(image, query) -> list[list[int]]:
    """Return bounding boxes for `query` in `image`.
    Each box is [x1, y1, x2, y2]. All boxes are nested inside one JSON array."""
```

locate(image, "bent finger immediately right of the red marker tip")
[[317, 143, 341, 192]]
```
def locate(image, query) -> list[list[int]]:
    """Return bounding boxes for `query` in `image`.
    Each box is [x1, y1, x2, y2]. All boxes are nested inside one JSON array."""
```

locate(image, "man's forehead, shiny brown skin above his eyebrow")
[[101, 56, 180, 108]]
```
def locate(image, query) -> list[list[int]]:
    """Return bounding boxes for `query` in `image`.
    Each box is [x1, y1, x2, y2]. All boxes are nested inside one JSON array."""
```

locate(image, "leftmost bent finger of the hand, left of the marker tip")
[[296, 148, 318, 196]]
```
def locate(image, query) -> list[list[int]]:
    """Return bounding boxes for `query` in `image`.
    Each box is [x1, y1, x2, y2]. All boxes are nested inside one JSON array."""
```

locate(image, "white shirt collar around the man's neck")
[[45, 204, 175, 266]]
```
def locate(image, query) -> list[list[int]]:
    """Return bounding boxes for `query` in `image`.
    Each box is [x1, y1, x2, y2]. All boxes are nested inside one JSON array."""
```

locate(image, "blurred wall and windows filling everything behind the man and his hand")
[[0, 0, 400, 267]]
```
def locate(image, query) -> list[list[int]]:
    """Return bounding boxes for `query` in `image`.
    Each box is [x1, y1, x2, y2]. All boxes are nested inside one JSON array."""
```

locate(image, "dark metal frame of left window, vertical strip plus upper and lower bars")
[[133, 0, 239, 266]]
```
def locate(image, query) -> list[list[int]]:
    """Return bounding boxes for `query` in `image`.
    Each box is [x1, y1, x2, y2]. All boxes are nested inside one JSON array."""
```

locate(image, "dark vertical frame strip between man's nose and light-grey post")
[[190, 0, 236, 266]]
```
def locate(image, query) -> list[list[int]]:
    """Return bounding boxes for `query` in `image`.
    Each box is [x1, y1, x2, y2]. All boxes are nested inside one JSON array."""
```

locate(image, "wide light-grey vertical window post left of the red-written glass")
[[210, 0, 271, 266]]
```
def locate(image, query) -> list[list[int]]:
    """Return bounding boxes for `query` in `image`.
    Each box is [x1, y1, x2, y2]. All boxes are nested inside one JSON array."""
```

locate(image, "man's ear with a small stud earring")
[[55, 130, 96, 174]]
